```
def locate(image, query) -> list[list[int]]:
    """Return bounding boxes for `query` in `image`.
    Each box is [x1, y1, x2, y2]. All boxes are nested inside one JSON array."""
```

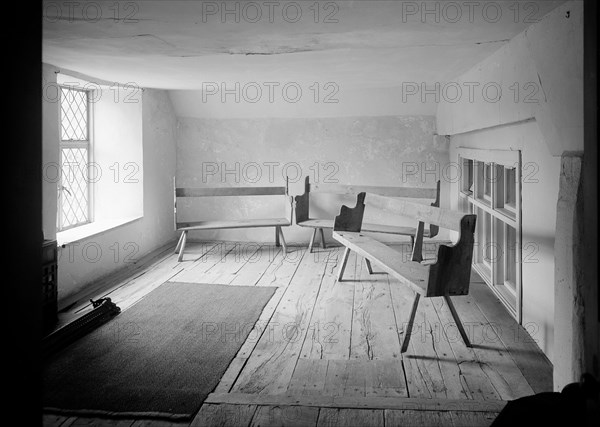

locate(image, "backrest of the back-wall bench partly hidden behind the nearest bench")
[[295, 176, 440, 237]]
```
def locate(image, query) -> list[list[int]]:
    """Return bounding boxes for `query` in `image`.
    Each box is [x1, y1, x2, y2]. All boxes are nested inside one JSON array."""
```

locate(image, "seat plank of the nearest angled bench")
[[333, 231, 430, 294]]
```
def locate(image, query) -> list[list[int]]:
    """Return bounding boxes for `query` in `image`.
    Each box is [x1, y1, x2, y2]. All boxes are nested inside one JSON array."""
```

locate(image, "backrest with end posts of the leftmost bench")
[[173, 177, 292, 229]]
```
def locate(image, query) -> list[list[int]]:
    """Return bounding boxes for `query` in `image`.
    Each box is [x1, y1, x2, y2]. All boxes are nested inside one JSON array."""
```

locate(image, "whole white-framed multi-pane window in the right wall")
[[458, 148, 521, 322]]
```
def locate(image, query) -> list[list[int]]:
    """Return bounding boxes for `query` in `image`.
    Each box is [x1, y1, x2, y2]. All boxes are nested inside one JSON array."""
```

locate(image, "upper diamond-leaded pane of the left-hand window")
[[60, 87, 88, 141]]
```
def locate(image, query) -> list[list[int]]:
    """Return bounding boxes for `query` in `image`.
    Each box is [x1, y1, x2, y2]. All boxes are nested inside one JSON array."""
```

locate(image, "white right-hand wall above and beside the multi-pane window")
[[436, 1, 583, 360]]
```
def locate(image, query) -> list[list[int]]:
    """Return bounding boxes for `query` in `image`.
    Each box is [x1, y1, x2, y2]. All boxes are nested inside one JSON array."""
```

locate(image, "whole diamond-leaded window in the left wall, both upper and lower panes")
[[57, 87, 91, 231]]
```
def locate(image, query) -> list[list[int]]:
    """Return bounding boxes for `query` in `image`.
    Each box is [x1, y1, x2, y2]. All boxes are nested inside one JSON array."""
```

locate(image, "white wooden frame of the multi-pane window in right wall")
[[457, 147, 523, 324]]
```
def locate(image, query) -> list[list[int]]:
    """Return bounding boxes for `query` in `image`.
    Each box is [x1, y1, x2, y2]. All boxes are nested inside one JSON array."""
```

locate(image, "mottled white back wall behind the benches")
[[177, 116, 448, 244]]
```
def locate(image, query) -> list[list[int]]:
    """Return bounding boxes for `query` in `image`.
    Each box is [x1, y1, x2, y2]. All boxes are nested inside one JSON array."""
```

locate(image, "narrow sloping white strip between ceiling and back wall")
[[169, 85, 436, 119]]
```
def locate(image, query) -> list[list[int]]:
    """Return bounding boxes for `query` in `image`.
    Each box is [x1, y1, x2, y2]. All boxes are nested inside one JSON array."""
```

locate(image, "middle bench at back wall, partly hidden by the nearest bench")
[[295, 176, 440, 252]]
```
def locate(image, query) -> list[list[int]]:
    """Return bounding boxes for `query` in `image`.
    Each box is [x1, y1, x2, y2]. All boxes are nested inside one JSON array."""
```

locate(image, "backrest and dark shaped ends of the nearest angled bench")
[[334, 193, 477, 297]]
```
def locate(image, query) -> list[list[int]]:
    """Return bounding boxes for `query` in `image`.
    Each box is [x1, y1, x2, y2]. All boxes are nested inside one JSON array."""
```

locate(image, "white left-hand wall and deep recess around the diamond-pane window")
[[43, 64, 176, 307]]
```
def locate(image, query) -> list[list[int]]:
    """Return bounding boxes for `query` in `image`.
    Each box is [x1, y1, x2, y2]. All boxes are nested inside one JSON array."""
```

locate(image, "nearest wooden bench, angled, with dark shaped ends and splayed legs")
[[333, 193, 477, 352]]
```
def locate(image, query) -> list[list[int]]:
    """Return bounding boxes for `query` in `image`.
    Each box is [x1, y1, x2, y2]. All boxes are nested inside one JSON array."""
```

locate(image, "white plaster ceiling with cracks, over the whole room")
[[43, 0, 563, 90]]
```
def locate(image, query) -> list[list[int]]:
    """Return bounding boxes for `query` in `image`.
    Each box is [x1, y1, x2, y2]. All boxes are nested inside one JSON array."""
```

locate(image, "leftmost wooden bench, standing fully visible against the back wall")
[[173, 179, 292, 261]]
